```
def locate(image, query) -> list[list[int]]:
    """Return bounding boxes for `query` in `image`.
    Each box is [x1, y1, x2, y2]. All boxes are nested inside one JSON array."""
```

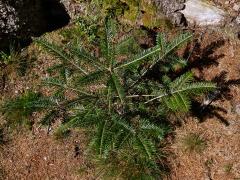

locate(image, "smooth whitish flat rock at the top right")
[[181, 0, 225, 26]]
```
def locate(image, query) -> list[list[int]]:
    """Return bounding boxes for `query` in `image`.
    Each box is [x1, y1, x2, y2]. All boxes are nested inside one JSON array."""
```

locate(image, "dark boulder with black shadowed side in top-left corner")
[[0, 0, 69, 49]]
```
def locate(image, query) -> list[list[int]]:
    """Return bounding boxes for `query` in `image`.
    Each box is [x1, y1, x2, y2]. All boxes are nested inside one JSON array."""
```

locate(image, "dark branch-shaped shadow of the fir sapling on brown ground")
[[171, 39, 240, 126]]
